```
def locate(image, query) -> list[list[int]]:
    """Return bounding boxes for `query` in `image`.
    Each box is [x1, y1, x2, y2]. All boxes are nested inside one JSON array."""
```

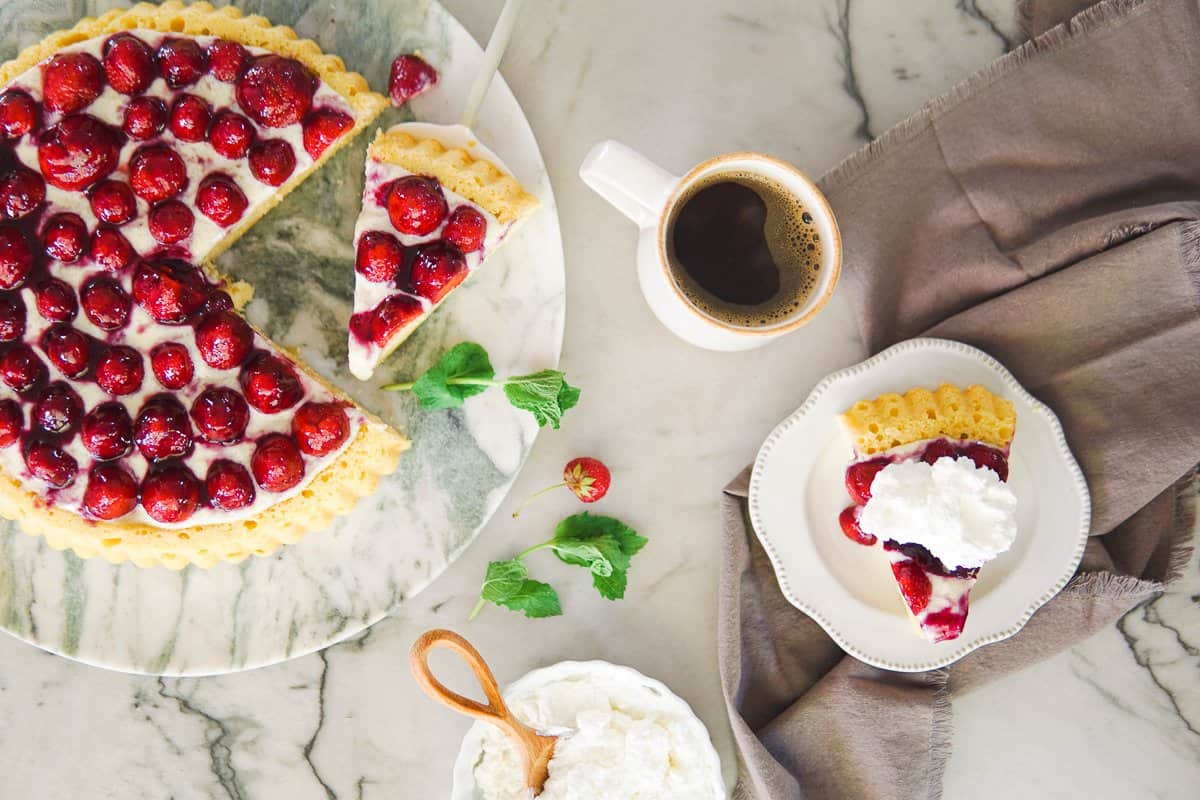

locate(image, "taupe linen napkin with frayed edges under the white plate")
[[719, 0, 1200, 800]]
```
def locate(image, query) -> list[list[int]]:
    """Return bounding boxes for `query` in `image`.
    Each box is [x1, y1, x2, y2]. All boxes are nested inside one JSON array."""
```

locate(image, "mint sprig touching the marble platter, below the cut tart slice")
[[384, 342, 580, 428]]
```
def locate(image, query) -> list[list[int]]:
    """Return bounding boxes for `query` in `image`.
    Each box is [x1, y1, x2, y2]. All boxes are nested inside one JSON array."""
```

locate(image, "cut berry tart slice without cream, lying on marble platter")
[[349, 122, 538, 380]]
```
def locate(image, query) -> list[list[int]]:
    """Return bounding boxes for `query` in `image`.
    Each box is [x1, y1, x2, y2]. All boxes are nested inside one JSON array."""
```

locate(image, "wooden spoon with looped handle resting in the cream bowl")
[[409, 630, 558, 796]]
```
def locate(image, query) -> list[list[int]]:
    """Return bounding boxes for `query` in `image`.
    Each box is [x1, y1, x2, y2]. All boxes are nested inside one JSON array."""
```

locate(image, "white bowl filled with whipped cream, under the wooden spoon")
[[450, 661, 726, 800]]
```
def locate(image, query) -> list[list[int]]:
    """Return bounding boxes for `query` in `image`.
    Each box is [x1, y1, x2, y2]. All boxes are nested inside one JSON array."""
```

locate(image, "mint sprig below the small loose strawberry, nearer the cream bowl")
[[468, 511, 648, 619]]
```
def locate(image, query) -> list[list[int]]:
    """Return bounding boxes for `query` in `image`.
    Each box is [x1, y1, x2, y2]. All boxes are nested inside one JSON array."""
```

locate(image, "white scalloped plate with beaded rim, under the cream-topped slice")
[[749, 338, 1091, 672]]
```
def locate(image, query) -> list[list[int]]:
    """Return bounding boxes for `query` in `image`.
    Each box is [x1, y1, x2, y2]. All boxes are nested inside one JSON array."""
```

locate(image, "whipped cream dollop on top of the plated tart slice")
[[859, 456, 1016, 570]]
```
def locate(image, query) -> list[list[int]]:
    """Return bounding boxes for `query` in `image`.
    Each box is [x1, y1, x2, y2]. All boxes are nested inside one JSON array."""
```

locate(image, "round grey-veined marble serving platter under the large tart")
[[0, 0, 565, 675]]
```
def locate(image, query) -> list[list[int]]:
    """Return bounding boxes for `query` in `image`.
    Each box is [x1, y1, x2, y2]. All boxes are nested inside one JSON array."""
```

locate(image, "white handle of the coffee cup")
[[580, 139, 679, 228]]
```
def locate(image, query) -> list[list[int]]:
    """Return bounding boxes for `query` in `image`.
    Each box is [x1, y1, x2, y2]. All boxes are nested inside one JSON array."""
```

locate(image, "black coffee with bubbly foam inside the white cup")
[[667, 170, 821, 327]]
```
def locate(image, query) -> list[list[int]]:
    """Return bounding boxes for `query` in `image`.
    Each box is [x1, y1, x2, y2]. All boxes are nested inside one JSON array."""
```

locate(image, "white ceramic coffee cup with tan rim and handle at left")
[[580, 139, 841, 350]]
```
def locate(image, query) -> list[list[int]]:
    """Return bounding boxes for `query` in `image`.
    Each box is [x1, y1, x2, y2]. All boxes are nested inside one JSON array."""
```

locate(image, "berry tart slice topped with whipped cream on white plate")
[[839, 384, 1016, 643]]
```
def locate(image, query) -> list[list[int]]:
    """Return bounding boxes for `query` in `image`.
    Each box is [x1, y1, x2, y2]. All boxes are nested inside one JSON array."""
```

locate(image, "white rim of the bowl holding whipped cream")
[[450, 661, 727, 800]]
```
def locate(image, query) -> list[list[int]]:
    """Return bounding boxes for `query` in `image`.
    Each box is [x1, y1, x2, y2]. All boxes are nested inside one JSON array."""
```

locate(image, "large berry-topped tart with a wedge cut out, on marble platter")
[[0, 2, 407, 569]]
